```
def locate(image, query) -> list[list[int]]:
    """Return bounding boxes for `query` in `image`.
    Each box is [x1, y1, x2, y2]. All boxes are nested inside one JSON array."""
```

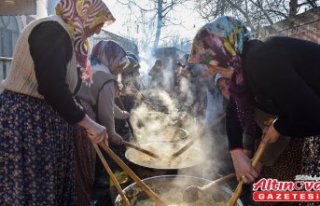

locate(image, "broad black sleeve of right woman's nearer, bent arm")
[[247, 48, 320, 137]]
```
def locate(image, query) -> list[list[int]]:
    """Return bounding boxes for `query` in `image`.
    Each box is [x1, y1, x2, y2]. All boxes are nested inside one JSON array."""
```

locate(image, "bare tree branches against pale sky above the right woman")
[[196, 0, 319, 34]]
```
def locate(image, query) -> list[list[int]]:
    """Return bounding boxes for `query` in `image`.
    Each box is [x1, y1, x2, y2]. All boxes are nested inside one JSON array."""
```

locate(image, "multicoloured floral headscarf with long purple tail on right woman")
[[189, 16, 257, 136]]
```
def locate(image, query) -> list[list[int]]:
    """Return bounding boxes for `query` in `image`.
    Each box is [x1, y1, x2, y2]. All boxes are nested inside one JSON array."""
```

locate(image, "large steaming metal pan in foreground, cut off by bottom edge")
[[115, 175, 243, 206]]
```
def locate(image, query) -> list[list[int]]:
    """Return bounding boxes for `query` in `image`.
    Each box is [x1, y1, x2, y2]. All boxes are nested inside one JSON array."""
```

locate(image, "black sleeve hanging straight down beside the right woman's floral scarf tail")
[[226, 97, 243, 150]]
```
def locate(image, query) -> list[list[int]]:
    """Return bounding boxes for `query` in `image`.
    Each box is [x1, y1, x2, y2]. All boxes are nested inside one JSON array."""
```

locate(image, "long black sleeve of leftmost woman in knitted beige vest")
[[28, 21, 85, 124]]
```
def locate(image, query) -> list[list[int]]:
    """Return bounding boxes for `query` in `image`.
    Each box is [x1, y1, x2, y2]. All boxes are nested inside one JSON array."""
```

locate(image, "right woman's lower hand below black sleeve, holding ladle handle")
[[230, 149, 259, 183]]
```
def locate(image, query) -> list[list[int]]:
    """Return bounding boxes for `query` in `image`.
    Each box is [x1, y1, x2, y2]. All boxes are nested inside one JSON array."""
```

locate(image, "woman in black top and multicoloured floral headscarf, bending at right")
[[189, 17, 320, 190]]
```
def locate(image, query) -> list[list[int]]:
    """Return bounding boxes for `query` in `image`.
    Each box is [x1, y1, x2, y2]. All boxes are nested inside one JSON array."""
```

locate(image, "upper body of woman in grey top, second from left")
[[77, 40, 130, 144]]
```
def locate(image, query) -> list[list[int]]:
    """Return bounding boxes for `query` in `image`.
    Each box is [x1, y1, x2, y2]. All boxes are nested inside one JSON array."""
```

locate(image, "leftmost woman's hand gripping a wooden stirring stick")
[[78, 115, 109, 145]]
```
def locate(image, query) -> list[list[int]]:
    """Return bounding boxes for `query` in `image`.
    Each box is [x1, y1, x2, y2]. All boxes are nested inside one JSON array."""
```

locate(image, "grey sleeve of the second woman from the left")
[[97, 81, 116, 136]]
